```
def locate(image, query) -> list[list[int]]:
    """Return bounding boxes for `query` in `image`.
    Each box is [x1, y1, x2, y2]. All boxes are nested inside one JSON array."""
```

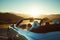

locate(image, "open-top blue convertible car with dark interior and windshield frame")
[[0, 18, 60, 40]]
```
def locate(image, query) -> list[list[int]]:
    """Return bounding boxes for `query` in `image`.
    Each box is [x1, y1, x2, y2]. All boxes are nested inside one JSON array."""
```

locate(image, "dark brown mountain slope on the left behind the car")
[[0, 12, 23, 24]]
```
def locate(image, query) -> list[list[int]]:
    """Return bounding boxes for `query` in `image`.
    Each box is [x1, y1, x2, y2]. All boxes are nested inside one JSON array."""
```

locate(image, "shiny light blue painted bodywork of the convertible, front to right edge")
[[9, 27, 60, 40]]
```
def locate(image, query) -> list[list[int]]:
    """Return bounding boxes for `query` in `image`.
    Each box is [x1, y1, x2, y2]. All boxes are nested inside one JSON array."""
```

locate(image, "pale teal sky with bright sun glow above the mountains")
[[0, 0, 60, 15]]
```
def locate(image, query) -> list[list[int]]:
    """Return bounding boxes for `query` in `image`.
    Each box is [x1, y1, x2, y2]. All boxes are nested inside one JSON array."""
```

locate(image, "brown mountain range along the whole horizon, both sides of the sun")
[[0, 12, 60, 24]]
